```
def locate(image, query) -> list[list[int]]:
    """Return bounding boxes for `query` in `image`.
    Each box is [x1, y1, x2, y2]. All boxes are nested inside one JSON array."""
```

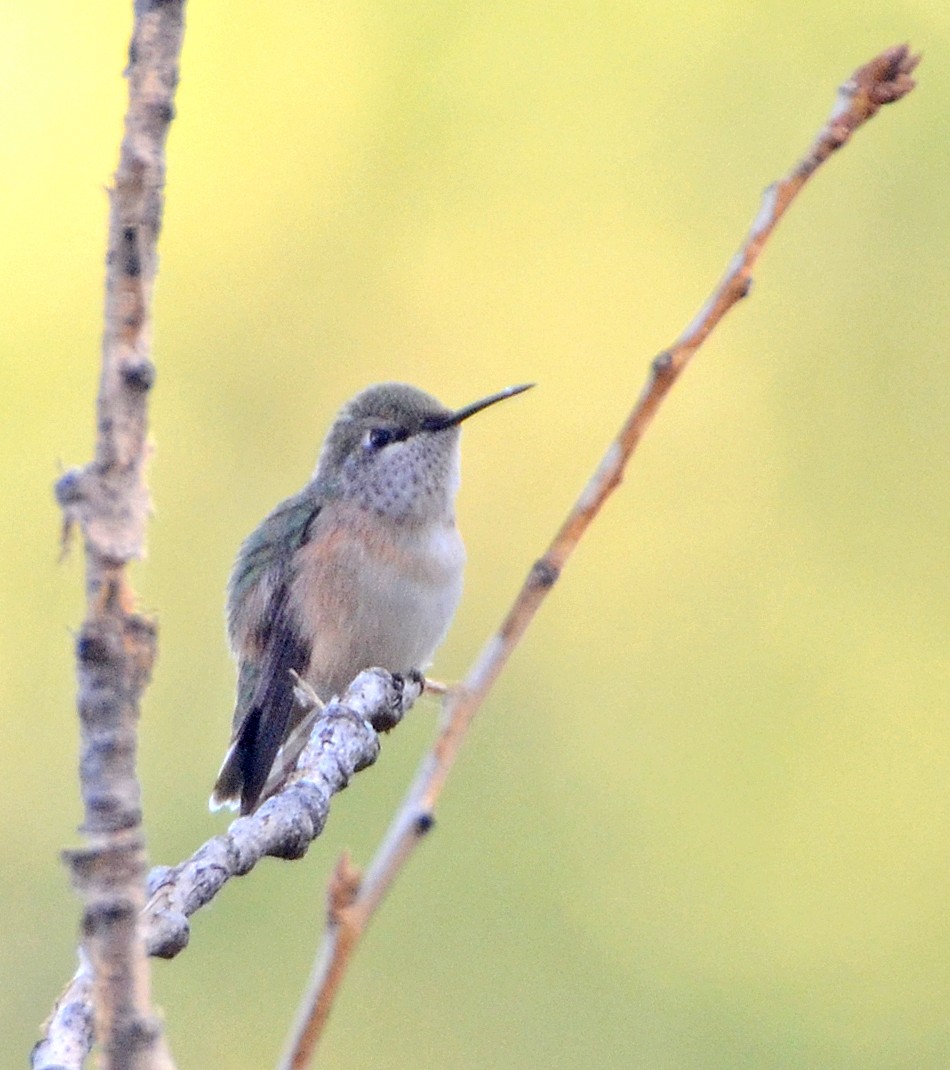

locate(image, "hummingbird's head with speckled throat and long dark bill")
[[316, 383, 527, 522]]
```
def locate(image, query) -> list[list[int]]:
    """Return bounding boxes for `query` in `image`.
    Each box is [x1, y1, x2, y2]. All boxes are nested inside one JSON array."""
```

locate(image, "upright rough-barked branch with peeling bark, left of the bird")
[[32, 0, 184, 1070]]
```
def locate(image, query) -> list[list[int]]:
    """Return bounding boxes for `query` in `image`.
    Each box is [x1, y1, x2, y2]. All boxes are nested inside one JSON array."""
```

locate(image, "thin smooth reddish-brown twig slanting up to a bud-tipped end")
[[280, 45, 920, 1070]]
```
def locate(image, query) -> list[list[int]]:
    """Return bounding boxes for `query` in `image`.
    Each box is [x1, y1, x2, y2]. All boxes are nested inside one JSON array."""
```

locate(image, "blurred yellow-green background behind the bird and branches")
[[0, 0, 950, 1070]]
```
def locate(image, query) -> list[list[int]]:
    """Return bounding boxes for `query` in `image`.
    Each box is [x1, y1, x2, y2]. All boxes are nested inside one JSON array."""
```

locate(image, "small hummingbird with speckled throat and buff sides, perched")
[[210, 383, 533, 813]]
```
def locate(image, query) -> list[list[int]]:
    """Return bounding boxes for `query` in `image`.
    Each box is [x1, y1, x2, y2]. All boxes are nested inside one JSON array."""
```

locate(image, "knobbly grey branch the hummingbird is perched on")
[[33, 669, 424, 1070]]
